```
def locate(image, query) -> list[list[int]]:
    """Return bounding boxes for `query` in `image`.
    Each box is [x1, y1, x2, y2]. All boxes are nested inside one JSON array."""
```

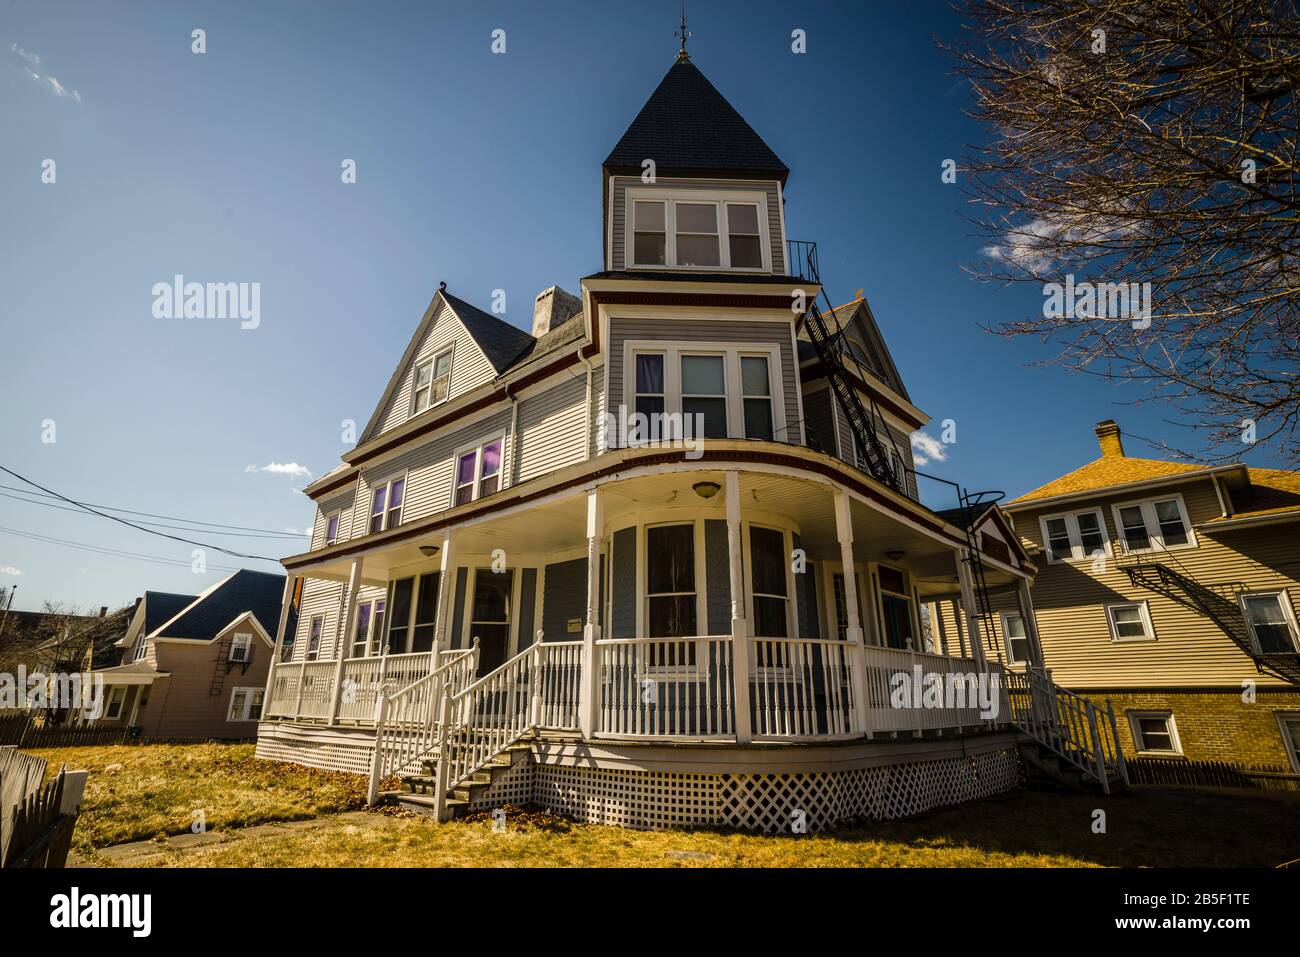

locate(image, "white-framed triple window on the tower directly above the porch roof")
[[623, 342, 785, 445]]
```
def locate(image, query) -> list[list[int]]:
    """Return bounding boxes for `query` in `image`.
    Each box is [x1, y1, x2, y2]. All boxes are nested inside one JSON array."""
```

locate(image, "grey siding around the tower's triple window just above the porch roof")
[[607, 319, 803, 445]]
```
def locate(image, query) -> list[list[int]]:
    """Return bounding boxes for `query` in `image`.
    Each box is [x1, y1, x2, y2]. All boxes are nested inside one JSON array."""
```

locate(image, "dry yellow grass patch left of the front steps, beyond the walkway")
[[31, 744, 365, 850]]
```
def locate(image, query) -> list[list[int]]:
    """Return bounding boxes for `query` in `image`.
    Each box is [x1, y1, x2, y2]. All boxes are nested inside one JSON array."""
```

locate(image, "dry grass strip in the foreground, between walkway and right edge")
[[131, 791, 1300, 867]]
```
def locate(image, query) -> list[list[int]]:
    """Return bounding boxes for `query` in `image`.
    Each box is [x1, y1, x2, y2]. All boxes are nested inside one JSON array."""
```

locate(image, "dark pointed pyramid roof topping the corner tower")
[[605, 60, 790, 183]]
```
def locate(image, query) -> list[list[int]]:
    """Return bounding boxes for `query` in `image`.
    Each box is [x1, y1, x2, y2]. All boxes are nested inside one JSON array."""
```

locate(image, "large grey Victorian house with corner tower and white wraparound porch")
[[257, 55, 1115, 831]]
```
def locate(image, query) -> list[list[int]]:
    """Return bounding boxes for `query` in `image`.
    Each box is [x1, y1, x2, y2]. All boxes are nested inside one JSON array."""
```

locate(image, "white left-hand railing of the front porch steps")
[[367, 638, 478, 805]]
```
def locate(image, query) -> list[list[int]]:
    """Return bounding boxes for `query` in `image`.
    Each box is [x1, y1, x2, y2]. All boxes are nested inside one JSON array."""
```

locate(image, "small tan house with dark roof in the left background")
[[81, 570, 293, 740]]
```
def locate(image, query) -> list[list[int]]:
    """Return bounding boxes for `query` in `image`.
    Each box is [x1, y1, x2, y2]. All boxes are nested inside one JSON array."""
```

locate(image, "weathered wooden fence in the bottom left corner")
[[0, 746, 86, 867]]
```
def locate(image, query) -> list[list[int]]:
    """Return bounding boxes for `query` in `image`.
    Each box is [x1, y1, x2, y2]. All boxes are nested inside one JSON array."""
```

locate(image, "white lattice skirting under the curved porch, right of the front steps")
[[472, 748, 1021, 833]]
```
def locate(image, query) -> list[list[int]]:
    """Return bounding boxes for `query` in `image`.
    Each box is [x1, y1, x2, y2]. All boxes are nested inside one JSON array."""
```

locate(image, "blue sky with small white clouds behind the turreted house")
[[0, 0, 1289, 609]]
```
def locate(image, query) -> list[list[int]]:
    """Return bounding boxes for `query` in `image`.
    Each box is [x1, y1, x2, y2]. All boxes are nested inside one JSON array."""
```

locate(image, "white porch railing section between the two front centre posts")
[[595, 636, 736, 739]]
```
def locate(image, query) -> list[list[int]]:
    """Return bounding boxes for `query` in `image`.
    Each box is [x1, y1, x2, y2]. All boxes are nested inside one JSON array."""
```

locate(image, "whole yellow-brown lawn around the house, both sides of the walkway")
[[38, 745, 1300, 867]]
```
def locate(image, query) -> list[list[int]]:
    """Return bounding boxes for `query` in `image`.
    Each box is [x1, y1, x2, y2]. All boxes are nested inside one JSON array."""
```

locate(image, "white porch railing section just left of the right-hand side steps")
[[865, 645, 993, 737]]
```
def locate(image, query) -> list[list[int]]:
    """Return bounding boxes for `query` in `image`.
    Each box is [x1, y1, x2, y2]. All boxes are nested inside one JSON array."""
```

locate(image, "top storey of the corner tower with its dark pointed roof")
[[603, 53, 789, 276]]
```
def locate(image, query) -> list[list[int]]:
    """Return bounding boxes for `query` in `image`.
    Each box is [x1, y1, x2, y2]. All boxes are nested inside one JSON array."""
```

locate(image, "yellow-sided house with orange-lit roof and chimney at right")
[[943, 420, 1300, 774]]
